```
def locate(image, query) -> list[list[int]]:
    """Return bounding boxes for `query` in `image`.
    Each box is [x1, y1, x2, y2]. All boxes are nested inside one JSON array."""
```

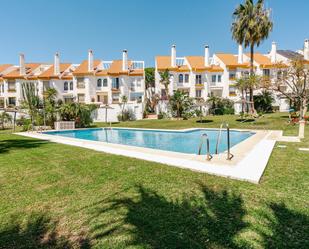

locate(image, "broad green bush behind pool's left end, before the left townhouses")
[[59, 102, 96, 128]]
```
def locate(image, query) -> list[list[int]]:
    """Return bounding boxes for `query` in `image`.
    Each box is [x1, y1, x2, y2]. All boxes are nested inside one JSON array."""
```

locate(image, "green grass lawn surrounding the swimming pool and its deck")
[[0, 114, 309, 248]]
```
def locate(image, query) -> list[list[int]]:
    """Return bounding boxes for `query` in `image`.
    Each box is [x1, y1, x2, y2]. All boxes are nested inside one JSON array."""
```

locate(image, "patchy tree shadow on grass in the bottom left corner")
[[0, 213, 91, 249]]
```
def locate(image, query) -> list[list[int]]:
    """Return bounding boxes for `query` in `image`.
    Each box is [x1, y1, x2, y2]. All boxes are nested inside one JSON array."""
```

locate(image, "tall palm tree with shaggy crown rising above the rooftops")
[[231, 0, 273, 111]]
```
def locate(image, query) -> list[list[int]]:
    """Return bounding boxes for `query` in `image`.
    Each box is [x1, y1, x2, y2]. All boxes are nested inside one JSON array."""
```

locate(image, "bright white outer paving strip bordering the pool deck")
[[16, 128, 276, 184]]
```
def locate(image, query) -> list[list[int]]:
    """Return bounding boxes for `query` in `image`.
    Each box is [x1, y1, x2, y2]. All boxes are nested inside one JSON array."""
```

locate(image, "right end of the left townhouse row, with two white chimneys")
[[73, 50, 145, 121]]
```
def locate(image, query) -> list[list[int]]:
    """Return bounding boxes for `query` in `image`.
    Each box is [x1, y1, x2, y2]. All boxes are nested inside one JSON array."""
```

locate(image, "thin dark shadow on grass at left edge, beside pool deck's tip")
[[0, 139, 47, 154]]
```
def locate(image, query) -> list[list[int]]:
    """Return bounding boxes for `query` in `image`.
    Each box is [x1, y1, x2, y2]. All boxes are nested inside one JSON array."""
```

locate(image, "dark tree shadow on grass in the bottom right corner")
[[258, 203, 309, 249]]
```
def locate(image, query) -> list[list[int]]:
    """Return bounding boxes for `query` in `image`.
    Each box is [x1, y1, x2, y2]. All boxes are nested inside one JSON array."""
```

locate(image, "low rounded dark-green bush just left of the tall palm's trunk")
[[207, 96, 235, 115]]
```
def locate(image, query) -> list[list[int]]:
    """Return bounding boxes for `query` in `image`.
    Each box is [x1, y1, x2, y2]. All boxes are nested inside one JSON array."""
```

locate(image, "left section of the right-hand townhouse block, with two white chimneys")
[[155, 45, 223, 104]]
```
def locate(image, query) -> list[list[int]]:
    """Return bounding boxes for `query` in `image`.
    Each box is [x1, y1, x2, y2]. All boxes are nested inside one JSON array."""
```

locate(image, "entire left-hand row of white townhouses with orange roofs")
[[0, 50, 145, 122]]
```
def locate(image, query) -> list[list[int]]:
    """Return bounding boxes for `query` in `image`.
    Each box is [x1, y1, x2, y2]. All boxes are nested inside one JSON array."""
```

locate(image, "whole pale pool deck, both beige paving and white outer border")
[[16, 127, 282, 183]]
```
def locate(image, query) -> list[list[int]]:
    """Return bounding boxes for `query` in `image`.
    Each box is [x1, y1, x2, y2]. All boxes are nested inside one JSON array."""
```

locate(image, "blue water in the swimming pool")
[[45, 128, 254, 154]]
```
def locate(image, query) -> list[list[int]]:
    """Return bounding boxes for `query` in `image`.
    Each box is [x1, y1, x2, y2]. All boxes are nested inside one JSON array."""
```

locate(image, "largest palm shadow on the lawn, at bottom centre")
[[92, 186, 248, 248]]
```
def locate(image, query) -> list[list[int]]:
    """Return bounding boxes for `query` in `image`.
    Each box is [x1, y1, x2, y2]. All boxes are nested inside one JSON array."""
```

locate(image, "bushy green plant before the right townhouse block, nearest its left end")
[[169, 90, 193, 118]]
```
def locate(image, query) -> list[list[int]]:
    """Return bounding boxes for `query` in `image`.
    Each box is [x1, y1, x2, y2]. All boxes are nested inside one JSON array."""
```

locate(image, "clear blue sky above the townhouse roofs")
[[0, 0, 309, 66]]
